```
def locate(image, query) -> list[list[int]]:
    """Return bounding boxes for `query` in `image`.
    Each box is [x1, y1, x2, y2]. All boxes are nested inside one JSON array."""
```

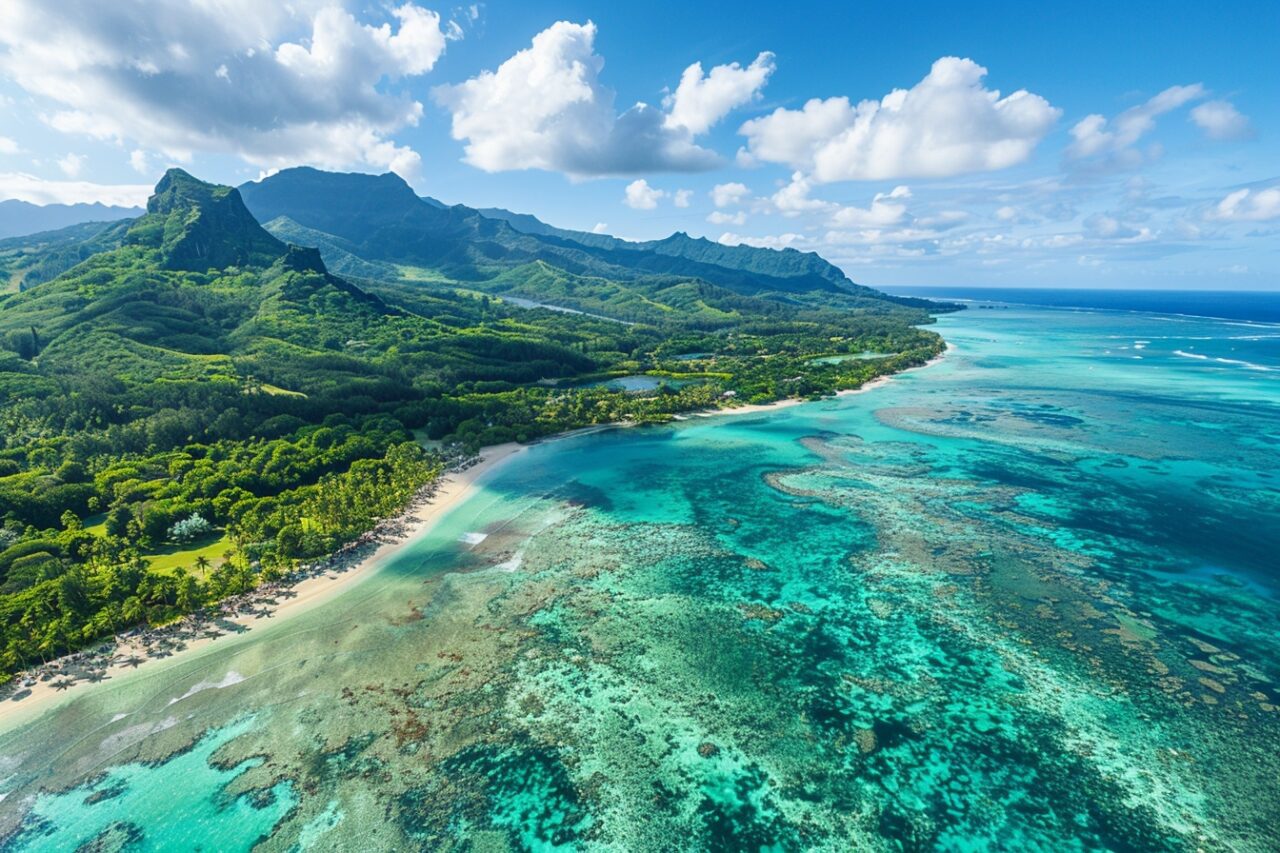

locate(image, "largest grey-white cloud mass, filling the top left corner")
[[0, 0, 447, 175]]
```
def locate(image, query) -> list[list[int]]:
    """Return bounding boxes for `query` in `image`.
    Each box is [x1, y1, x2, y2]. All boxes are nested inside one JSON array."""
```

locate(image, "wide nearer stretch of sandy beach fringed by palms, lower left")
[[0, 442, 529, 729]]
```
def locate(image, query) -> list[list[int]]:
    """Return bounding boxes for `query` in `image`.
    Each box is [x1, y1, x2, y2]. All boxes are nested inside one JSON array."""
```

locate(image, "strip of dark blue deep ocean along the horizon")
[[881, 287, 1280, 323]]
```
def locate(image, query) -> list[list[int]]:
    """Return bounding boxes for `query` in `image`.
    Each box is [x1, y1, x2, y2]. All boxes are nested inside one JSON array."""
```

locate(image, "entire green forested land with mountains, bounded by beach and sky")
[[0, 169, 947, 680]]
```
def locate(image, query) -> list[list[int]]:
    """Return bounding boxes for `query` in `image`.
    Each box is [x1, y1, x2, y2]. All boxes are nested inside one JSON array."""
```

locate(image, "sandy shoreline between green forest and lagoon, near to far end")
[[0, 345, 951, 731]]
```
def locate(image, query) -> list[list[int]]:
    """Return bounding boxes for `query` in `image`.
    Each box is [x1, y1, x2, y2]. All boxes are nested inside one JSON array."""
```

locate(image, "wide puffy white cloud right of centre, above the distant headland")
[[741, 56, 1061, 183]]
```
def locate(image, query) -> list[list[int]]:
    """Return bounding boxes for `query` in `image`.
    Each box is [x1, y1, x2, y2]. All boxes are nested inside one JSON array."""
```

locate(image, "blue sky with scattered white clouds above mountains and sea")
[[0, 0, 1280, 291]]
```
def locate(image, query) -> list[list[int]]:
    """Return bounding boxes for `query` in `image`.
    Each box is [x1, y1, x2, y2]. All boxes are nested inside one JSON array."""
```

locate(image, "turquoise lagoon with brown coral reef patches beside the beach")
[[0, 303, 1280, 850]]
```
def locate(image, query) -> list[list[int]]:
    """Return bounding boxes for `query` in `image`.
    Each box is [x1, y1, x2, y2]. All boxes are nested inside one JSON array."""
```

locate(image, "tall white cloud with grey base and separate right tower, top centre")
[[433, 20, 772, 177]]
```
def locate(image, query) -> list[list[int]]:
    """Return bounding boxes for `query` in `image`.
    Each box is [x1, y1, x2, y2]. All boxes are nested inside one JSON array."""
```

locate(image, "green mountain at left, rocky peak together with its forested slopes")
[[0, 169, 422, 415]]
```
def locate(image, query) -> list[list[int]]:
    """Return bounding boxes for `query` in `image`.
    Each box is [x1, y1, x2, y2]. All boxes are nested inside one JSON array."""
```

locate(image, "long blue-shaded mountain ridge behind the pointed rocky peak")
[[239, 168, 927, 310]]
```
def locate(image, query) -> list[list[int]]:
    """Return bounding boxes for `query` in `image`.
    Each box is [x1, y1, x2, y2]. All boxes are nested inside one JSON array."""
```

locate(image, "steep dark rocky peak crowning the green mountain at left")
[[124, 169, 287, 272]]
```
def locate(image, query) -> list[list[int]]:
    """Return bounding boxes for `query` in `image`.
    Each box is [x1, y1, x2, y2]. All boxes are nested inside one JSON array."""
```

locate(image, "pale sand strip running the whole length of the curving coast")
[[0, 346, 950, 731]]
